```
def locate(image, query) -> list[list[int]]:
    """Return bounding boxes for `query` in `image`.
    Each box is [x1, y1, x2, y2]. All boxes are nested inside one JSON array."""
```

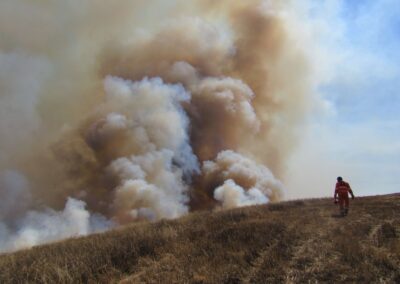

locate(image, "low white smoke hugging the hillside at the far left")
[[0, 170, 114, 252]]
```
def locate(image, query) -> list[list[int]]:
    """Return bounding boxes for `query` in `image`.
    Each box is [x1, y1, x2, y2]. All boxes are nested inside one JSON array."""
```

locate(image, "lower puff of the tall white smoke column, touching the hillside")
[[110, 149, 188, 220]]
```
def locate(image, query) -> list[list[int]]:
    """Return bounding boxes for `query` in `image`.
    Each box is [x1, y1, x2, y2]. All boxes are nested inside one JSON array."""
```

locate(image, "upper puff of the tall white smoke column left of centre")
[[100, 76, 198, 172]]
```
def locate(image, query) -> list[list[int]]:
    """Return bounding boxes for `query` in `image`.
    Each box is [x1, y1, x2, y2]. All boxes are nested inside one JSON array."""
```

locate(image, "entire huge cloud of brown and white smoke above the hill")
[[0, 0, 312, 251]]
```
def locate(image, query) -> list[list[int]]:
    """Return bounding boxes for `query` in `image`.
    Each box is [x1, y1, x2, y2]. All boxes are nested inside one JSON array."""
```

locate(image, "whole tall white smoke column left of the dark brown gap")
[[94, 77, 199, 222]]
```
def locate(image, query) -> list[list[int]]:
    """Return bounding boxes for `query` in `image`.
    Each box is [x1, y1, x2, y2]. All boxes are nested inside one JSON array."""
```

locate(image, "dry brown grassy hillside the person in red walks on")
[[0, 194, 400, 283]]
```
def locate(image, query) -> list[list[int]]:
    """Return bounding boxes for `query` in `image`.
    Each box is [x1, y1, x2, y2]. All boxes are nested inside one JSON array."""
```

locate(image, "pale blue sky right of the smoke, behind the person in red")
[[287, 0, 400, 198]]
